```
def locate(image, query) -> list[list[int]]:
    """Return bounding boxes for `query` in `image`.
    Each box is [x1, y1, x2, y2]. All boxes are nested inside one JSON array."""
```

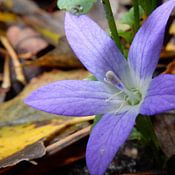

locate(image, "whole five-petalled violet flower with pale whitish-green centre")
[[25, 0, 175, 175]]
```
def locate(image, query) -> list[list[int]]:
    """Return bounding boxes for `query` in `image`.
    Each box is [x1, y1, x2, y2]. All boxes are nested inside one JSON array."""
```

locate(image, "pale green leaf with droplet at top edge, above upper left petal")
[[57, 0, 97, 15]]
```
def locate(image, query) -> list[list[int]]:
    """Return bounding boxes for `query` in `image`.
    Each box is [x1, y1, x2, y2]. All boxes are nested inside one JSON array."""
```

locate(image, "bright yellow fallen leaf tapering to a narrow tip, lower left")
[[0, 116, 94, 160]]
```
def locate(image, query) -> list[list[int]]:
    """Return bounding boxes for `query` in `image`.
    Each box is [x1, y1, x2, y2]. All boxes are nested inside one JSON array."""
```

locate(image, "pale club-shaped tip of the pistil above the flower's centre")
[[105, 71, 124, 90]]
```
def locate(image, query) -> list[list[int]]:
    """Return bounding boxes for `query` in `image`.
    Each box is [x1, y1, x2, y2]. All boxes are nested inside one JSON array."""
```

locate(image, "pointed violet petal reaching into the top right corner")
[[128, 0, 175, 79]]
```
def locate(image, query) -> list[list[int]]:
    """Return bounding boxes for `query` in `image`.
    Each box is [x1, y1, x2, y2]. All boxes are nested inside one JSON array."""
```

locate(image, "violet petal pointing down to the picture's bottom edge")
[[86, 111, 138, 175]]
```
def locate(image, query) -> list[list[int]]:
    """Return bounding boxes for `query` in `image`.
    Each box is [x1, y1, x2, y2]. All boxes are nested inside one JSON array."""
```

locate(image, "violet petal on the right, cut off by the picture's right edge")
[[140, 74, 175, 115]]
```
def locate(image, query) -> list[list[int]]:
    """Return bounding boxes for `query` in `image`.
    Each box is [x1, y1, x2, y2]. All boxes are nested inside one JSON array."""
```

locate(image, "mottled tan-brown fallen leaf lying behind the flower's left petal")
[[0, 69, 89, 126]]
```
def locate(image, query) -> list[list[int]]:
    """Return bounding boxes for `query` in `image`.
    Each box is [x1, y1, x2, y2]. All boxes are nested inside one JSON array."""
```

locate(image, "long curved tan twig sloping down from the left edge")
[[0, 36, 26, 84]]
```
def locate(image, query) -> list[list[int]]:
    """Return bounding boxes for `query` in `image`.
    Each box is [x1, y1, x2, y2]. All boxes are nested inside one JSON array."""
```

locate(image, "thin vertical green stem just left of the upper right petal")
[[133, 0, 140, 33]]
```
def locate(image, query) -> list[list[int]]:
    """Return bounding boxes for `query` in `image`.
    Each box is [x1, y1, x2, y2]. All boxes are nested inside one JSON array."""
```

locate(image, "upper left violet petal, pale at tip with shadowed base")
[[65, 13, 131, 87]]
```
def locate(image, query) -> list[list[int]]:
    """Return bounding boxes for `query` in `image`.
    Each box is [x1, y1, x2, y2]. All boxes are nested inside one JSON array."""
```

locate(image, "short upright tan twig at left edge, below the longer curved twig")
[[2, 54, 11, 89]]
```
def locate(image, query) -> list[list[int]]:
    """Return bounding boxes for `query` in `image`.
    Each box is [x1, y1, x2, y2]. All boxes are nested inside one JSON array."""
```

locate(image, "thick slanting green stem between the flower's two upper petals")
[[102, 0, 123, 52]]
